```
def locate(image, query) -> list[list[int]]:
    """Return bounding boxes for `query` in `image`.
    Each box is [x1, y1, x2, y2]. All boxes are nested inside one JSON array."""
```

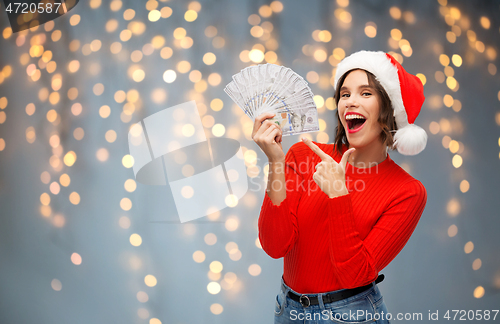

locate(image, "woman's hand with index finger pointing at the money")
[[302, 138, 355, 198]]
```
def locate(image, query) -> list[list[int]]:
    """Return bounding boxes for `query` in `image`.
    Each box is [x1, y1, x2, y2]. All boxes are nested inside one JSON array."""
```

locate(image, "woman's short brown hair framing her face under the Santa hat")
[[335, 69, 398, 155]]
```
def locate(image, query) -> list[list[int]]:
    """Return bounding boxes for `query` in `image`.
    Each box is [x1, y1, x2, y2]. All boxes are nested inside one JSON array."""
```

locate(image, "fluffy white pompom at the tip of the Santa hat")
[[394, 124, 427, 155]]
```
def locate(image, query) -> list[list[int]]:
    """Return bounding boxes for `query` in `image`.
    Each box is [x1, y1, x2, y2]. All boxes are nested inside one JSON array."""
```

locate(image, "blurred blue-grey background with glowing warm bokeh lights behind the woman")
[[0, 0, 500, 324]]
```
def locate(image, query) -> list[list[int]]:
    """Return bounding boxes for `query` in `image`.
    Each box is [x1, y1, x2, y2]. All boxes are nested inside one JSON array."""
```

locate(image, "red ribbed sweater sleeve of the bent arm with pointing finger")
[[327, 179, 427, 288]]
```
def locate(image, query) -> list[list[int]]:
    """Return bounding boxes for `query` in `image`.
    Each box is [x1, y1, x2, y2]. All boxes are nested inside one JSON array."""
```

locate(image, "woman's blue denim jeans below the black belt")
[[274, 277, 390, 324]]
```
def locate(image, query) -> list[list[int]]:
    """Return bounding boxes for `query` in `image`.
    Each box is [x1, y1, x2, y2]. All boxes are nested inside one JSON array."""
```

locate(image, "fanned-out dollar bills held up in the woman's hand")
[[224, 63, 319, 136]]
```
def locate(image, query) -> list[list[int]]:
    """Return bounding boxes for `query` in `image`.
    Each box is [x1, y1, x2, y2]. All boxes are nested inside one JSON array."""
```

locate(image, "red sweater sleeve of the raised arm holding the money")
[[258, 146, 303, 259]]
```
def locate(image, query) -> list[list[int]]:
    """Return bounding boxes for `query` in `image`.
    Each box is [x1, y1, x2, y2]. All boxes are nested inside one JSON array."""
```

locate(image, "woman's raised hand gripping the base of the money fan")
[[252, 112, 285, 162]]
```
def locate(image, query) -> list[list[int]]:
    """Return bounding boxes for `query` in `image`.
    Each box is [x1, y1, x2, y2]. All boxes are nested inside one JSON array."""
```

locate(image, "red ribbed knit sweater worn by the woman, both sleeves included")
[[258, 142, 427, 293]]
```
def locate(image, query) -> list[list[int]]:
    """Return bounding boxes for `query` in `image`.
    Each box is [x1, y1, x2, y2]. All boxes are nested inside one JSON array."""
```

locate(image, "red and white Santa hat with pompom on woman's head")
[[335, 51, 427, 155]]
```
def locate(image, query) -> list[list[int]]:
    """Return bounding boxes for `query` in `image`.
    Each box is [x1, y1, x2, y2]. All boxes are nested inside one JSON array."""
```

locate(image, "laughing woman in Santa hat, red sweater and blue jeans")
[[252, 51, 427, 323]]
